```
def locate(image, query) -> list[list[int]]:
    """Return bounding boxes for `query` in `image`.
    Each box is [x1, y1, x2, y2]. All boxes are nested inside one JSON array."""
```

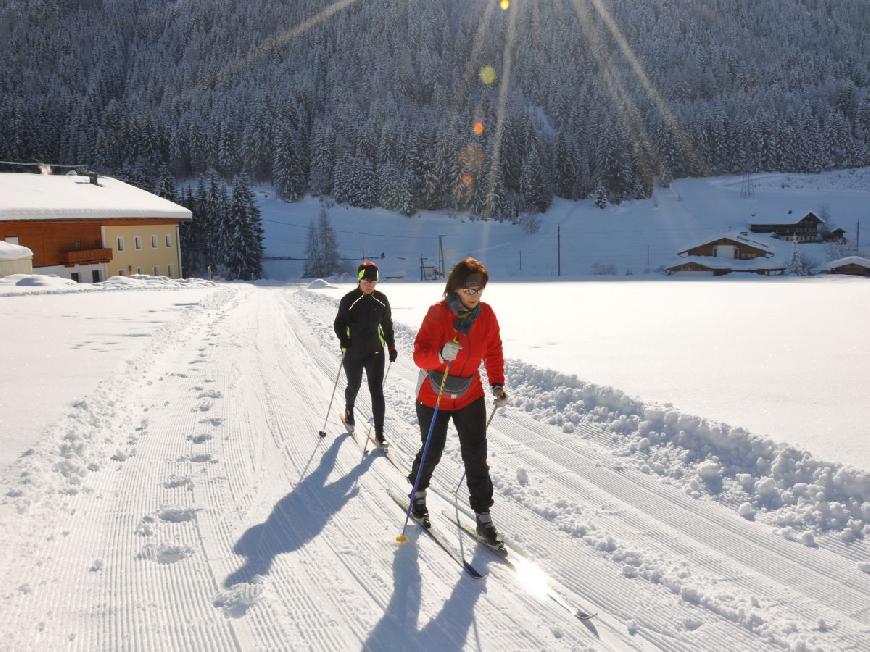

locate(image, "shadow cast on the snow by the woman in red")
[[363, 530, 486, 652]]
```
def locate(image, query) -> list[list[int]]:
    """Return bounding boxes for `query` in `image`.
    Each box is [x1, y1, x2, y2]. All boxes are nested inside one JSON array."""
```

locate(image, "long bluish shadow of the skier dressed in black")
[[224, 435, 377, 588]]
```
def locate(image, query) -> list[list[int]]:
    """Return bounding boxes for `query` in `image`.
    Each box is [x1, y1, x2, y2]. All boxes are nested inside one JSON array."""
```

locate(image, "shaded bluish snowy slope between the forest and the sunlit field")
[[258, 168, 870, 281]]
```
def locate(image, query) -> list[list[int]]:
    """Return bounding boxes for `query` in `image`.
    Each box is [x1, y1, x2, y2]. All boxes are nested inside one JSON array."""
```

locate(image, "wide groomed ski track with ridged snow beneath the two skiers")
[[0, 284, 870, 652]]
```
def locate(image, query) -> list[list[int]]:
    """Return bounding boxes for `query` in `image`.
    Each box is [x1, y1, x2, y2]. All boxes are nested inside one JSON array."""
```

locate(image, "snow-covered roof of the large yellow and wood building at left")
[[0, 173, 191, 221]]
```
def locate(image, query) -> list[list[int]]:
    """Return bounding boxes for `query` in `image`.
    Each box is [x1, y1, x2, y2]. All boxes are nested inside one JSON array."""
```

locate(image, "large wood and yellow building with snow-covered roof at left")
[[0, 173, 192, 283]]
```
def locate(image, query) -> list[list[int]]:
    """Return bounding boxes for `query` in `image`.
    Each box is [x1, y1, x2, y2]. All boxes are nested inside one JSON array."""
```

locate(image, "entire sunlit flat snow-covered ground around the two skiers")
[[0, 280, 870, 651]]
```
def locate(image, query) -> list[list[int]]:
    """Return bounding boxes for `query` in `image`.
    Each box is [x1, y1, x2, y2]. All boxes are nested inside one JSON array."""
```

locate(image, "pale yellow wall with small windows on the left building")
[[102, 224, 181, 278]]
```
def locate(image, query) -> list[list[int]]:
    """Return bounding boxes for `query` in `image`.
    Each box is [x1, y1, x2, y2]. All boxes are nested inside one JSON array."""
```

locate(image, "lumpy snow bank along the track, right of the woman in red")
[[507, 360, 870, 545]]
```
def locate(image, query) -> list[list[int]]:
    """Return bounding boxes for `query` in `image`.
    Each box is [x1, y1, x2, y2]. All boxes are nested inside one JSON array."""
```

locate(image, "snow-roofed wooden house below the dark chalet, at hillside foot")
[[665, 232, 786, 276]]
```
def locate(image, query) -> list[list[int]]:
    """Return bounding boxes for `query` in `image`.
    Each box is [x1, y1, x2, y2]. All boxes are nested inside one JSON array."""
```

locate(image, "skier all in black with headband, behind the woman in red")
[[333, 260, 399, 447]]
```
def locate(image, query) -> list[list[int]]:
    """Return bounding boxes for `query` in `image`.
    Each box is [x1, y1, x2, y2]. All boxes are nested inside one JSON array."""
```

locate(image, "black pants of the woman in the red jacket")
[[408, 396, 492, 512]]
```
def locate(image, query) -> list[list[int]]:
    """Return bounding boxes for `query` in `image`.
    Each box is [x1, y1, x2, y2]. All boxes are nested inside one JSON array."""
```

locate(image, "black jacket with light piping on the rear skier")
[[333, 288, 396, 355]]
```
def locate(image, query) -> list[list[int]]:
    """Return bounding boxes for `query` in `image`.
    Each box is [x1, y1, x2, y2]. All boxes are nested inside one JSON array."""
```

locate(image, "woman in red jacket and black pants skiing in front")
[[408, 258, 507, 546]]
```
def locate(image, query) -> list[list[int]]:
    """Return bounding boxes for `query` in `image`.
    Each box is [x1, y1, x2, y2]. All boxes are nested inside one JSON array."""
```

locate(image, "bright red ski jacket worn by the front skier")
[[414, 301, 504, 410]]
